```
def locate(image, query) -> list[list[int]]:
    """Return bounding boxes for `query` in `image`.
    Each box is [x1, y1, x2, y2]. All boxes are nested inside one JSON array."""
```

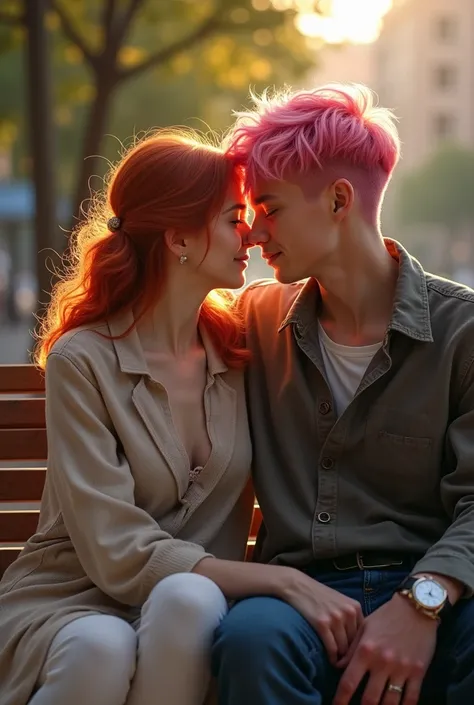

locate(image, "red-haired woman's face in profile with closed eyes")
[[197, 178, 250, 290]]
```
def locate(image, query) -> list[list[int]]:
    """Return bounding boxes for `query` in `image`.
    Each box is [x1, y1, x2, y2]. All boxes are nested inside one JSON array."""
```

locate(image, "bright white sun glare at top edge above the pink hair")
[[295, 0, 393, 44]]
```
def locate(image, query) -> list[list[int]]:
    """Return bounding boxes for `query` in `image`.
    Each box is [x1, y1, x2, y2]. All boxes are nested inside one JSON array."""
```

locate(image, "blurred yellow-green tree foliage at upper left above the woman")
[[0, 0, 314, 202]]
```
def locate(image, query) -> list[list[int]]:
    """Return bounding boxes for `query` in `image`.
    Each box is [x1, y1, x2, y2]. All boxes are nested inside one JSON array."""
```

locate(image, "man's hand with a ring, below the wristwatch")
[[333, 594, 438, 705]]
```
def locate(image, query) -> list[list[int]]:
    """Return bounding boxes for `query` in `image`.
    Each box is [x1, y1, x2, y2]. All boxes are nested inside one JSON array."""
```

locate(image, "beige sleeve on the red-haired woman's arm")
[[46, 351, 210, 606]]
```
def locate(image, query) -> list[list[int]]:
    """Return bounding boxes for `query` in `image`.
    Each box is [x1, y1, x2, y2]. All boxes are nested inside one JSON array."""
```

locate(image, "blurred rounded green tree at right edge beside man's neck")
[[399, 145, 474, 229]]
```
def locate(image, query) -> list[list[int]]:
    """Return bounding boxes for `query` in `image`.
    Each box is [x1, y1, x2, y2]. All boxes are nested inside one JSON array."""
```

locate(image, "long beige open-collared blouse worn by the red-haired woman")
[[0, 313, 253, 705]]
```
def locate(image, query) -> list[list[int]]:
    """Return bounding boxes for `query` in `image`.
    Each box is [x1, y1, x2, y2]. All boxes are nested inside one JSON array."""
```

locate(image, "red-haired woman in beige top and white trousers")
[[0, 131, 253, 705]]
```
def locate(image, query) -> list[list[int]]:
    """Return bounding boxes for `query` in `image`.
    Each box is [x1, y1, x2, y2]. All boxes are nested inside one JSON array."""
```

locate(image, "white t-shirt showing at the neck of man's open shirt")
[[318, 323, 382, 416]]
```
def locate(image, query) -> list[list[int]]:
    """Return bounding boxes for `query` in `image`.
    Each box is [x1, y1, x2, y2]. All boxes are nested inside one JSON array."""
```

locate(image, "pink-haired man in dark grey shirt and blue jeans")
[[212, 86, 474, 705]]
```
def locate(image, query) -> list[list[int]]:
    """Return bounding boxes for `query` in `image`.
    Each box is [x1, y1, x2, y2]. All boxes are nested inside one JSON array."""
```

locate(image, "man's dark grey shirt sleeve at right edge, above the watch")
[[412, 359, 474, 597]]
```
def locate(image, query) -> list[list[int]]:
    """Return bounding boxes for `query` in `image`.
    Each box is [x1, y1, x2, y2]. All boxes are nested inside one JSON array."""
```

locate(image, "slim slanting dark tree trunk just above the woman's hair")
[[73, 68, 117, 226]]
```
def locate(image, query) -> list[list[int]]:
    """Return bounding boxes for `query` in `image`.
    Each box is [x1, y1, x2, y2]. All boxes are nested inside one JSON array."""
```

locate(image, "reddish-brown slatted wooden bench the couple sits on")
[[0, 365, 261, 577]]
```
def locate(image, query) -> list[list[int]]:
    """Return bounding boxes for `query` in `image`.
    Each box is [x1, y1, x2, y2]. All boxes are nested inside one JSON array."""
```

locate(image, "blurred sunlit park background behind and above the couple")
[[0, 0, 474, 363]]
